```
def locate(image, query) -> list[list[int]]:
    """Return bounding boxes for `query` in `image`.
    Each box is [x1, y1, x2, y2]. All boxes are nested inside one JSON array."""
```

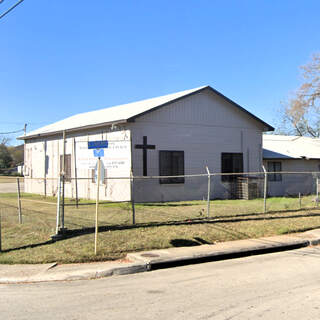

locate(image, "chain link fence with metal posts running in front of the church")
[[0, 171, 320, 251]]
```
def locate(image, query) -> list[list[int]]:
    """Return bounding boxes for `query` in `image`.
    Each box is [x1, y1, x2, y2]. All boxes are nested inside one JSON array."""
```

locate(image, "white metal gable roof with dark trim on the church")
[[18, 86, 274, 139]]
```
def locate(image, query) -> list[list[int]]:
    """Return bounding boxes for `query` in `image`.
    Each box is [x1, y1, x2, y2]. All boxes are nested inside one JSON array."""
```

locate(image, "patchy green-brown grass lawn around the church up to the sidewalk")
[[0, 194, 320, 263]]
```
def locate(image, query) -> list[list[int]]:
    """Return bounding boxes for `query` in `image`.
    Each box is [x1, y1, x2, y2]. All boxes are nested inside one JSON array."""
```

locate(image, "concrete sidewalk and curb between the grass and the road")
[[0, 229, 320, 284]]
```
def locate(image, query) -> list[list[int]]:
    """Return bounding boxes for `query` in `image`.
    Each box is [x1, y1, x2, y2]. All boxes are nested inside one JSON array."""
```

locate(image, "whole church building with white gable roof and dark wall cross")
[[20, 86, 273, 202]]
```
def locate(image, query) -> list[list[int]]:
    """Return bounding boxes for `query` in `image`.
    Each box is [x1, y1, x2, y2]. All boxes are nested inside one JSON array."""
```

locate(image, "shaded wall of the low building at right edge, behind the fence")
[[263, 159, 320, 197]]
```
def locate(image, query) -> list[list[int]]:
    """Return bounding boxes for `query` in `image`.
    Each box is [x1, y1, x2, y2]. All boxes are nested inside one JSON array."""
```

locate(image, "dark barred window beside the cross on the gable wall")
[[159, 151, 184, 184]]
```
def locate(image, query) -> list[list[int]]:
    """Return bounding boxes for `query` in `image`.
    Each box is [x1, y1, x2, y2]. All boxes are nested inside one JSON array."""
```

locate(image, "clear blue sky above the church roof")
[[0, 0, 320, 144]]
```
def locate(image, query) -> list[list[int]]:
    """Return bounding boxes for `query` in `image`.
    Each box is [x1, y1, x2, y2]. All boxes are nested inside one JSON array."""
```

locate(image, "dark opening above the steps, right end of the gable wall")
[[221, 152, 243, 181]]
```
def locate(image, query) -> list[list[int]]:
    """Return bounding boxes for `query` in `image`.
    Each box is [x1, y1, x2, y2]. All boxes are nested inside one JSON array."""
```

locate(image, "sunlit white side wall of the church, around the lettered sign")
[[25, 128, 131, 201]]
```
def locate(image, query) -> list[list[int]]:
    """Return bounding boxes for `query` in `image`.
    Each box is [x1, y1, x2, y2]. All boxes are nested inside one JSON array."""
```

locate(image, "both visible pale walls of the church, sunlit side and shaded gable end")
[[25, 90, 265, 202]]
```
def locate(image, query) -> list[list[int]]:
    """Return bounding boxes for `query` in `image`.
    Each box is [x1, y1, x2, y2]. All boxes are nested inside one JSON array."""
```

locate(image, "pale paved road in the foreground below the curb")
[[0, 247, 320, 320]]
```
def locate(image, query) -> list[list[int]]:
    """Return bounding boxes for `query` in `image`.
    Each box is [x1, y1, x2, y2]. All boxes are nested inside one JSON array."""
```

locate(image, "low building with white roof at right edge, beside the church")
[[263, 134, 320, 196]]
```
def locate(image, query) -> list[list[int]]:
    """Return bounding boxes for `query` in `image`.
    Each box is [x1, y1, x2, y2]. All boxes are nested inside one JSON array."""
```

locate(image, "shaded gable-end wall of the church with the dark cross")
[[129, 91, 263, 202]]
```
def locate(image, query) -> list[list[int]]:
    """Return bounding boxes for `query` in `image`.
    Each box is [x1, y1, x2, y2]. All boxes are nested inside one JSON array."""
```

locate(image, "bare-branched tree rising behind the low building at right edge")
[[279, 53, 320, 137]]
